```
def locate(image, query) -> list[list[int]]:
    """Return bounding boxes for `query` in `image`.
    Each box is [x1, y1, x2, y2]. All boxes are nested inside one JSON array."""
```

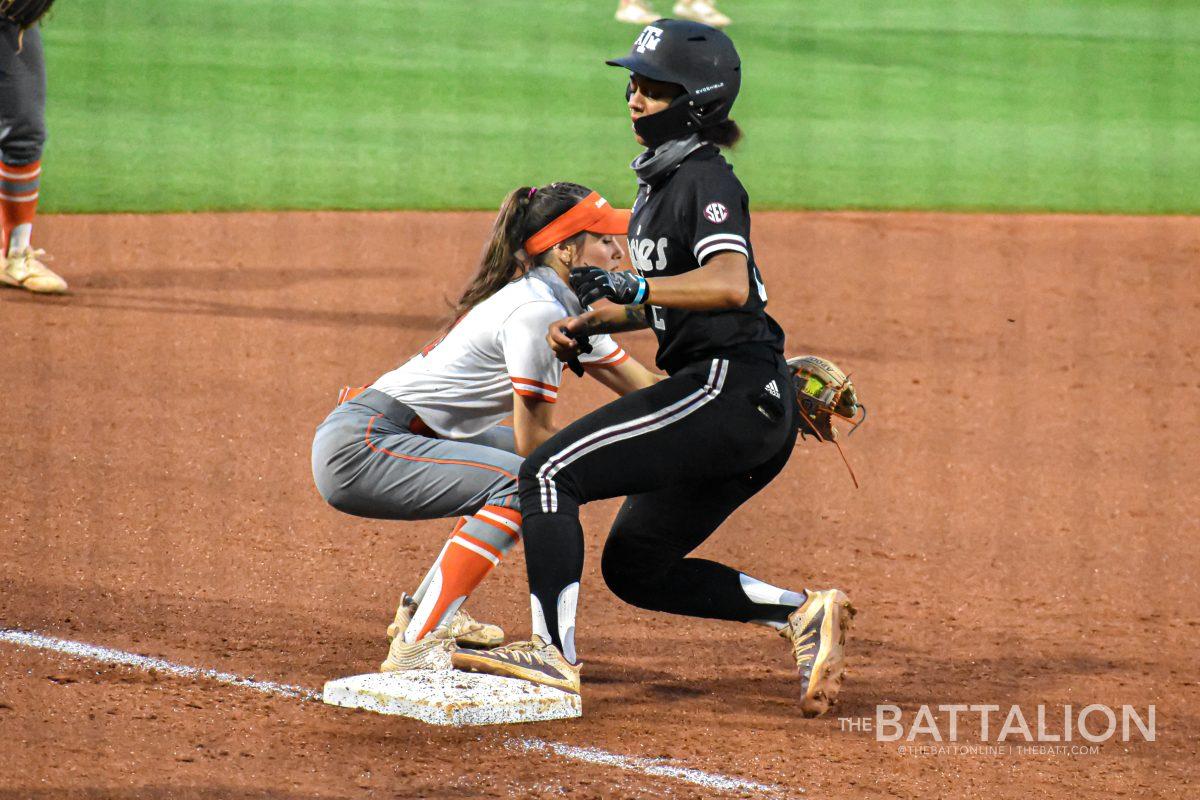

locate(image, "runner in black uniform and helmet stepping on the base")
[[454, 19, 853, 715]]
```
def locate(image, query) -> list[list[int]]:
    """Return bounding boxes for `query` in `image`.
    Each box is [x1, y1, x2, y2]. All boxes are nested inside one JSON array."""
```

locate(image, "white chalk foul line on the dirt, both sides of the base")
[[0, 628, 804, 798]]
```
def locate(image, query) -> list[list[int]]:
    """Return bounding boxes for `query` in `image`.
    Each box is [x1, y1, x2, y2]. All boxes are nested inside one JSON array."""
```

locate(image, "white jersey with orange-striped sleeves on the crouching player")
[[371, 275, 629, 439]]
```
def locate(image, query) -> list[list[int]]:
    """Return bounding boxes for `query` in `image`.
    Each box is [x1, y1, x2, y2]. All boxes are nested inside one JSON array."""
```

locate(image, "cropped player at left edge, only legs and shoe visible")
[[0, 0, 67, 294]]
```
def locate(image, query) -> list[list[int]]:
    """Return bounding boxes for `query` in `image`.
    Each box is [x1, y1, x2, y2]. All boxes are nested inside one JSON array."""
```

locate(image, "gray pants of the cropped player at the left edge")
[[0, 20, 46, 167]]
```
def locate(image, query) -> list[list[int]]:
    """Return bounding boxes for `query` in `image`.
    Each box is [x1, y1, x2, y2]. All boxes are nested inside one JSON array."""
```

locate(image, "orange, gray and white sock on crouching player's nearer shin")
[[404, 506, 521, 642]]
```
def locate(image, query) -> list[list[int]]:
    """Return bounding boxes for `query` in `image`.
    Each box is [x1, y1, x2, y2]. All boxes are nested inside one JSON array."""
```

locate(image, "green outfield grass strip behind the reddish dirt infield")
[[42, 0, 1200, 213]]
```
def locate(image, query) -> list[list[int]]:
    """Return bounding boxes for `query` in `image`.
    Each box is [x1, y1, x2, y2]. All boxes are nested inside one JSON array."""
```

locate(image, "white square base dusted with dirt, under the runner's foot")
[[322, 669, 583, 727]]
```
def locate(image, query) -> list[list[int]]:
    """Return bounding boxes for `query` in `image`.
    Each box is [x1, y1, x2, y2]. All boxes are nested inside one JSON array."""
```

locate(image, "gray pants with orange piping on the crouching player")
[[312, 389, 522, 525]]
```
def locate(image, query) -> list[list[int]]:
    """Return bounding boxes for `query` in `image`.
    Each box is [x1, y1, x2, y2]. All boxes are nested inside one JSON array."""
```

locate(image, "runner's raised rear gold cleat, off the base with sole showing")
[[779, 589, 857, 717]]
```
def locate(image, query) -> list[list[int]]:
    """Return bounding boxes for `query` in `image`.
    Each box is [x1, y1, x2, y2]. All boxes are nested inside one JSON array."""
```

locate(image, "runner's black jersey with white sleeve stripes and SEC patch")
[[629, 144, 784, 374]]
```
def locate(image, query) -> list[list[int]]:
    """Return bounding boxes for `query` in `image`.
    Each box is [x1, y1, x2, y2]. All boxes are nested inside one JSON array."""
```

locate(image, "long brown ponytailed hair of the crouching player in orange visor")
[[454, 181, 592, 319]]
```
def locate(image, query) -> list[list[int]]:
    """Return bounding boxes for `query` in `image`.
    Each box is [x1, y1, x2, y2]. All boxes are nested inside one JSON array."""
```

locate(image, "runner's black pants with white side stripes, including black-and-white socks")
[[520, 359, 797, 660]]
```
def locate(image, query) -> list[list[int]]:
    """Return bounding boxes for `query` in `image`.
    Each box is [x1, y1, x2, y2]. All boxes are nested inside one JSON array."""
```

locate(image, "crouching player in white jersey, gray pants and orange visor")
[[312, 182, 658, 672]]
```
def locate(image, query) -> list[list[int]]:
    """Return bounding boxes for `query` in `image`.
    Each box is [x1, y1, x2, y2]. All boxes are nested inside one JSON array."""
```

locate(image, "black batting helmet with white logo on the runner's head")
[[606, 19, 742, 148]]
